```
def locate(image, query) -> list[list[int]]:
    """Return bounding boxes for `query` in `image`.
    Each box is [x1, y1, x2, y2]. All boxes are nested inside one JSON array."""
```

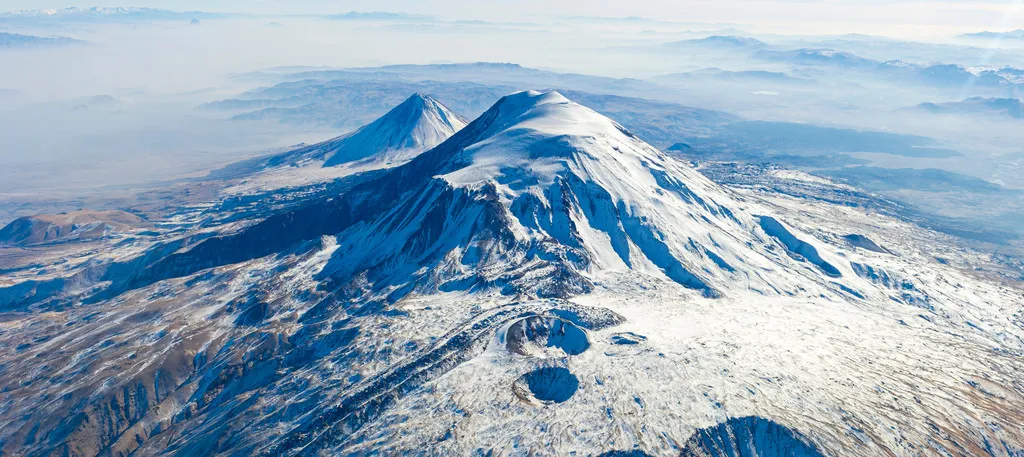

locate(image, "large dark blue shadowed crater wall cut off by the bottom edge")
[[681, 416, 824, 457]]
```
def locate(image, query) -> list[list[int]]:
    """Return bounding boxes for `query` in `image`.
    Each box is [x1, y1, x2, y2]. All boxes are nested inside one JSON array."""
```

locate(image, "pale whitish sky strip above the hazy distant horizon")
[[0, 0, 1024, 37]]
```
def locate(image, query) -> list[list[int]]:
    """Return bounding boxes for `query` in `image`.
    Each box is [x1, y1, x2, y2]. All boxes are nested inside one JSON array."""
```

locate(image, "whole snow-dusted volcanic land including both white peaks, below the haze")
[[0, 91, 1024, 457]]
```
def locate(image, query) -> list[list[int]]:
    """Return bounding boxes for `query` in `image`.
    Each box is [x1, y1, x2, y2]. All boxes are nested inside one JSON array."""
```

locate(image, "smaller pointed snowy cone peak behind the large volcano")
[[324, 93, 467, 167]]
